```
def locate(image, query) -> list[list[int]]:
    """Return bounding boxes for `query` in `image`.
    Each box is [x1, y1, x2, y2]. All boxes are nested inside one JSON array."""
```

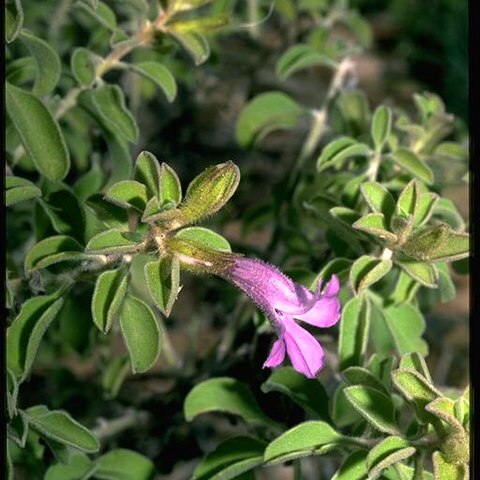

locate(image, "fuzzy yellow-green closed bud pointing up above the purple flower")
[[180, 161, 240, 224]]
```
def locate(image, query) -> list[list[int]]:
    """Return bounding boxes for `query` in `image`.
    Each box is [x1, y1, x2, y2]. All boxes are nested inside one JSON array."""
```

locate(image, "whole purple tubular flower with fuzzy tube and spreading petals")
[[222, 256, 340, 378]]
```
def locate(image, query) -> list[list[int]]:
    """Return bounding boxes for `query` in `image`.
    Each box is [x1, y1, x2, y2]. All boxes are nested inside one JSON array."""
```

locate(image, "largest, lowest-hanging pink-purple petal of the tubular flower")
[[283, 317, 324, 378]]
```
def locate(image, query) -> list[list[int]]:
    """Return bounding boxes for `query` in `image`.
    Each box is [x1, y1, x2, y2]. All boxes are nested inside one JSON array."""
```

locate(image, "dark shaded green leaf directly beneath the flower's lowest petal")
[[261, 367, 330, 421]]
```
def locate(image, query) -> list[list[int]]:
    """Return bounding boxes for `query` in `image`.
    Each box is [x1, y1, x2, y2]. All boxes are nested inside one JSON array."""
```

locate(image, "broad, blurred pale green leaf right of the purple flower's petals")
[[384, 303, 428, 355]]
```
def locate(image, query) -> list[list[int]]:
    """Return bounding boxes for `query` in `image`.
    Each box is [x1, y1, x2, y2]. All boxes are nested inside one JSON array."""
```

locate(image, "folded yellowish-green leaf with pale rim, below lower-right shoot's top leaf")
[[392, 368, 442, 423]]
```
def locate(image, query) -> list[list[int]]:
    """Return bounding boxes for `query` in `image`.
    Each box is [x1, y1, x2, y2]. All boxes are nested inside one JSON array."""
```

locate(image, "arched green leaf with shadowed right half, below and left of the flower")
[[183, 377, 278, 428]]
